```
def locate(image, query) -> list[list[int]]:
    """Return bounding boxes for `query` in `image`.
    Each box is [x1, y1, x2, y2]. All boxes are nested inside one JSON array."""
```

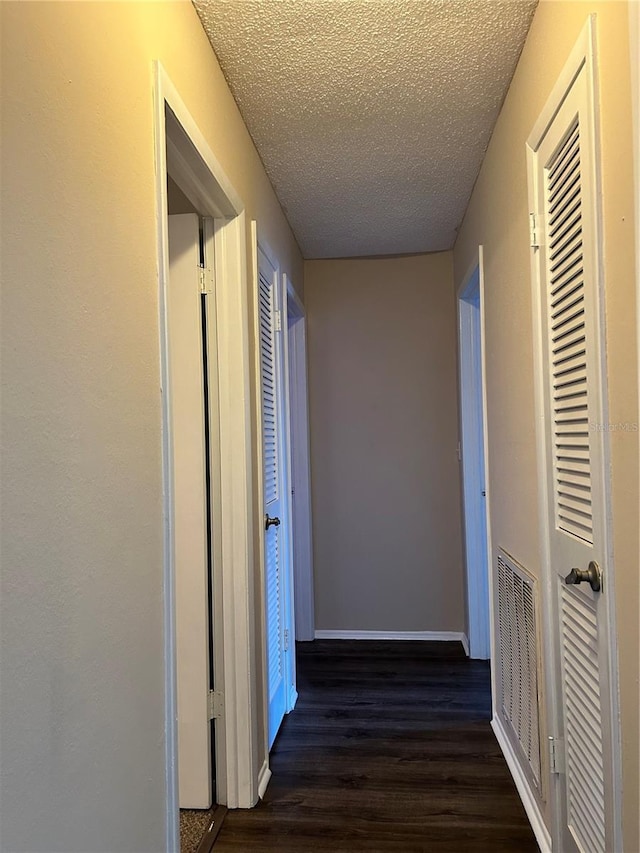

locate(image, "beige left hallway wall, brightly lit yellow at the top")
[[0, 2, 303, 853]]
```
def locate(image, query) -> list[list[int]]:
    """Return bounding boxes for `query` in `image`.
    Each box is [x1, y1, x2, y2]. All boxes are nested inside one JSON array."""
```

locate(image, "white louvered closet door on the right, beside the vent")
[[534, 56, 614, 853]]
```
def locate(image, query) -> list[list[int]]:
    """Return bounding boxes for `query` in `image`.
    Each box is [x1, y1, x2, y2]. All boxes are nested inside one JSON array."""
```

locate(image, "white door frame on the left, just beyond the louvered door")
[[284, 275, 315, 641]]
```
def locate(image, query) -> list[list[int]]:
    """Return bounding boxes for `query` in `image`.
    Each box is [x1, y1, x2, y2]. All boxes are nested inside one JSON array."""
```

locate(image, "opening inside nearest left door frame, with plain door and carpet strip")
[[167, 206, 218, 851]]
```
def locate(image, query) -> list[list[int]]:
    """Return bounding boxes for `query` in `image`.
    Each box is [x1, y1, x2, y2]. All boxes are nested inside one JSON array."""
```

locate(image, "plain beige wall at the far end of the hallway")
[[305, 253, 464, 631]]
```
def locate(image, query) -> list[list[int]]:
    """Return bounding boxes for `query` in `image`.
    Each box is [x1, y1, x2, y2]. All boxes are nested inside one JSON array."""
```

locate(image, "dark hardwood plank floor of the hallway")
[[214, 640, 538, 853]]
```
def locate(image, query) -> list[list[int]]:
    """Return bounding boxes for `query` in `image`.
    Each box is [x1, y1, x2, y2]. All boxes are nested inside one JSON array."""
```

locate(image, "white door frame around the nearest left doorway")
[[153, 61, 257, 849]]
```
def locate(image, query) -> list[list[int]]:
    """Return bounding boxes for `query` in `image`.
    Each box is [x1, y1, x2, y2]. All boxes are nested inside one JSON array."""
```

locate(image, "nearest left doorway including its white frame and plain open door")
[[155, 63, 258, 849]]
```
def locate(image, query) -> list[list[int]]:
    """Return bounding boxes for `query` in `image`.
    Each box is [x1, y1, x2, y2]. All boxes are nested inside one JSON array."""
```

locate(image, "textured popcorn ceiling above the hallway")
[[194, 0, 537, 258]]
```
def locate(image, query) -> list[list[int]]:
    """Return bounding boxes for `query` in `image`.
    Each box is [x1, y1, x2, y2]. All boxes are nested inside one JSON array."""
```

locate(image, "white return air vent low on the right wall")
[[497, 549, 540, 790]]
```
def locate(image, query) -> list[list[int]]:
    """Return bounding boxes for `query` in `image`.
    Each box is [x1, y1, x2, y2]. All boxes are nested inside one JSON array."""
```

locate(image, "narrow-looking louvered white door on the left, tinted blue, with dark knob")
[[258, 248, 287, 749]]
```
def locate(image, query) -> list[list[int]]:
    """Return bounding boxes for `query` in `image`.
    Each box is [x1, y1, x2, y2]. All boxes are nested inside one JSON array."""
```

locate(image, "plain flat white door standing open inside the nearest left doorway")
[[168, 213, 212, 809]]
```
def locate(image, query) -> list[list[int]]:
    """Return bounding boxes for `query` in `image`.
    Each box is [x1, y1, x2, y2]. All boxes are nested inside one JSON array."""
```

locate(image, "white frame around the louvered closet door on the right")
[[526, 14, 622, 850]]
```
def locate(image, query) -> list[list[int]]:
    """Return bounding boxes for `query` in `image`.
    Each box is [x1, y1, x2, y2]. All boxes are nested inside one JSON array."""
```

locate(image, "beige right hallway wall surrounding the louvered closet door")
[[454, 0, 640, 853]]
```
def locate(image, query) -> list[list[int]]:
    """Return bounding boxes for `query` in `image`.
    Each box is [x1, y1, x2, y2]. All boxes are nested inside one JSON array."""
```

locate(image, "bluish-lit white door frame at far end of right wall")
[[457, 246, 493, 660]]
